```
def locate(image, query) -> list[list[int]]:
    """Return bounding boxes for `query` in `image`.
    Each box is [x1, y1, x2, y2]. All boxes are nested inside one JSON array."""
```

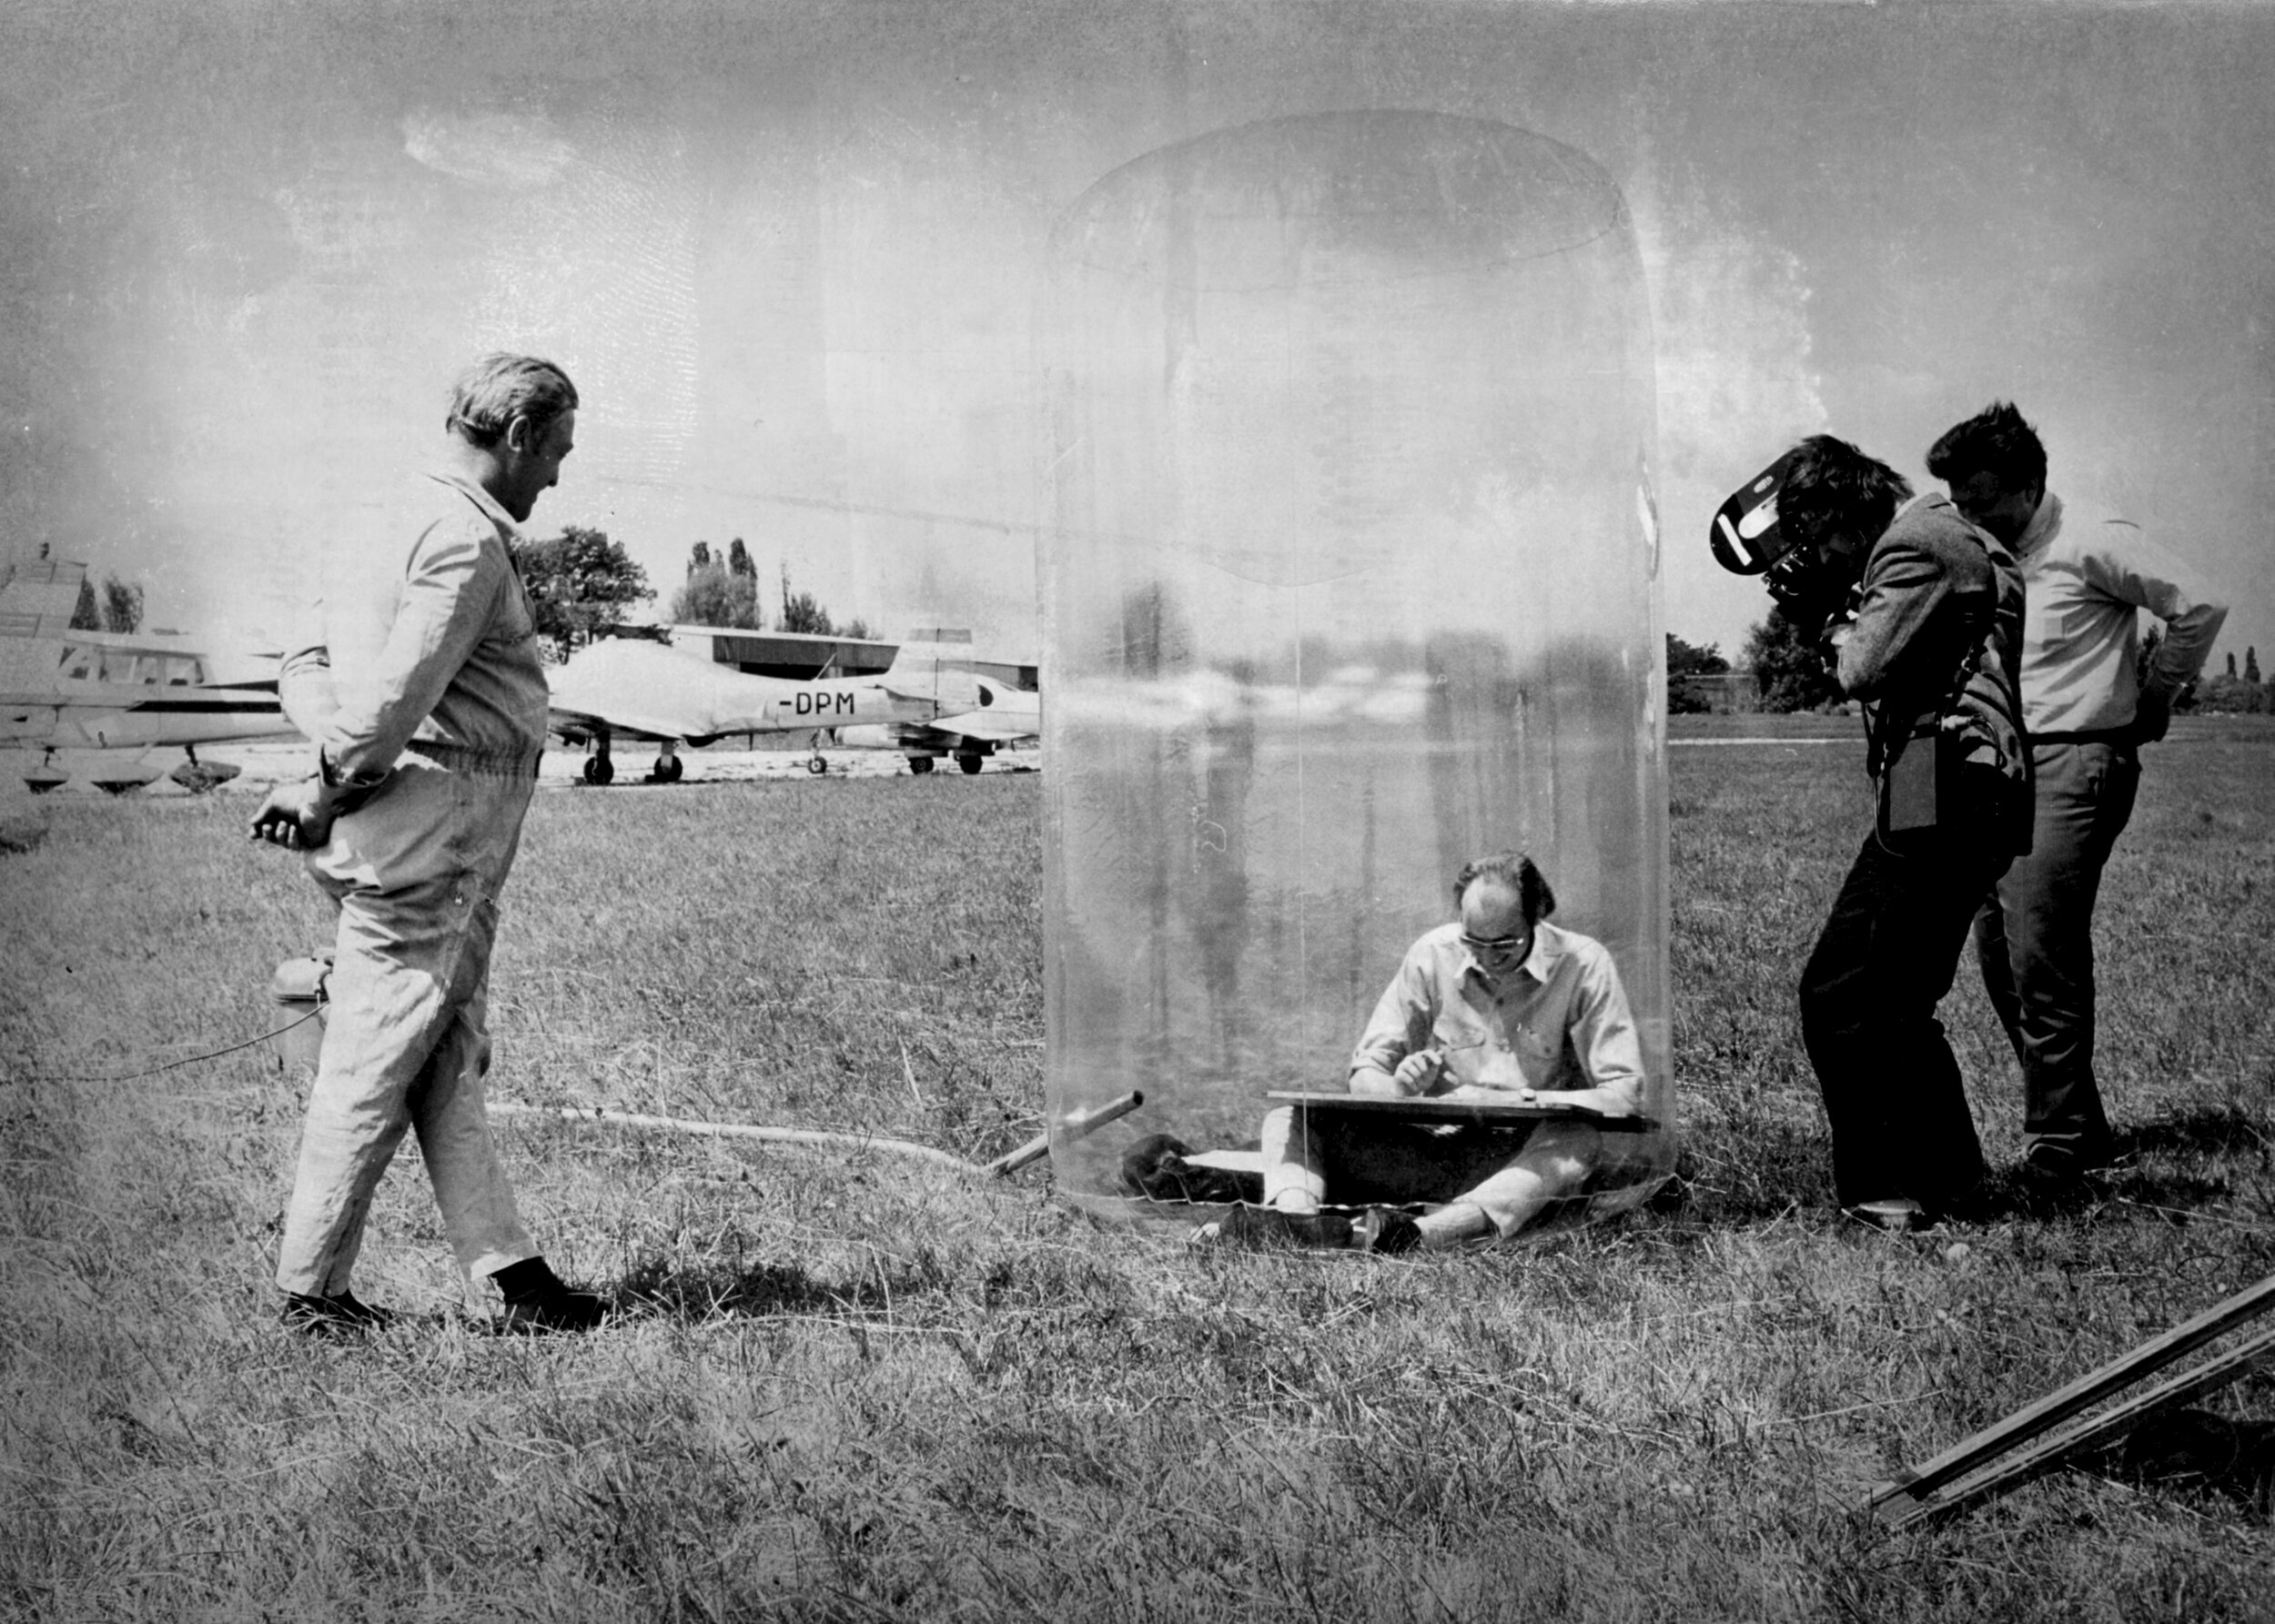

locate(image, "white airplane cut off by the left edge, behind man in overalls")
[[0, 558, 294, 794]]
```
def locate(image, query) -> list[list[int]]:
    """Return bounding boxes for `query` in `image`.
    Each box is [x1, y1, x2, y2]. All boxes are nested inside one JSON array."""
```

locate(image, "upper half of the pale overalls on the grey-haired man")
[[278, 473, 546, 778]]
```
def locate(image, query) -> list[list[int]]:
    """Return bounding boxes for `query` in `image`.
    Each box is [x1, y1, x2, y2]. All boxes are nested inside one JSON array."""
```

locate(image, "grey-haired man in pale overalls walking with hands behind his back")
[[250, 355, 603, 1337]]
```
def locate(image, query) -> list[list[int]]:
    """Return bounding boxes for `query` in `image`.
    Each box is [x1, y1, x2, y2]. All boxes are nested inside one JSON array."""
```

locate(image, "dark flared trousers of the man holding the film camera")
[[1802, 823, 2007, 1213]]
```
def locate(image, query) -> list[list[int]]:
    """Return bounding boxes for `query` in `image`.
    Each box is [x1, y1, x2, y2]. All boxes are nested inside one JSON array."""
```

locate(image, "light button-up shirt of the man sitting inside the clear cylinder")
[[1351, 922, 1643, 1104]]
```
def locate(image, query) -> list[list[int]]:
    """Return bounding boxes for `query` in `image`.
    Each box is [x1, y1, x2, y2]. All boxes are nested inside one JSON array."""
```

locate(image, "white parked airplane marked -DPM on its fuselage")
[[549, 628, 1042, 785]]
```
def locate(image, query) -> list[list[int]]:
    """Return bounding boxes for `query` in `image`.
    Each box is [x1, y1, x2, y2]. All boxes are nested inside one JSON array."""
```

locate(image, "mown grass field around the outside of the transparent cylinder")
[[0, 719, 2275, 1622]]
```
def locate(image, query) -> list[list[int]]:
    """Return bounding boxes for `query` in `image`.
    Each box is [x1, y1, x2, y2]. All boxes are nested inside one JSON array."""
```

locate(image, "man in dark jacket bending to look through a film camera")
[[1715, 435, 2032, 1231]]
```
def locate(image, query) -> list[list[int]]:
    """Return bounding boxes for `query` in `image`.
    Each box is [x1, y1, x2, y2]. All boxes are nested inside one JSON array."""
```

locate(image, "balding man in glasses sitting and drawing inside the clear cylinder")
[[1218, 851, 1643, 1251]]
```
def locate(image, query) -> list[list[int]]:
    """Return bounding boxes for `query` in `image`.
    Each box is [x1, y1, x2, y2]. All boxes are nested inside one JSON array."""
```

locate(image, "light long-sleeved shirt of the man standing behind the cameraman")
[[2016, 491, 2228, 735]]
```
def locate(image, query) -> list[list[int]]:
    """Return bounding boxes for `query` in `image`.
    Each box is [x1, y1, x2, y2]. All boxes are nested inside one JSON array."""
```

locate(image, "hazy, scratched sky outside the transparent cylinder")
[[0, 0, 2275, 664]]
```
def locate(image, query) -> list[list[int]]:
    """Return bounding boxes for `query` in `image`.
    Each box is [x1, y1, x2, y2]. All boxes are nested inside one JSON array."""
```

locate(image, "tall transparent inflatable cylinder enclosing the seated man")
[[1042, 112, 1674, 1224]]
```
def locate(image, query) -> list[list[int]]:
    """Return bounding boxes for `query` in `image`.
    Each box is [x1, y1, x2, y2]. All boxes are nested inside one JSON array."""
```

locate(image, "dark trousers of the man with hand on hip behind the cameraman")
[[1975, 741, 2141, 1169]]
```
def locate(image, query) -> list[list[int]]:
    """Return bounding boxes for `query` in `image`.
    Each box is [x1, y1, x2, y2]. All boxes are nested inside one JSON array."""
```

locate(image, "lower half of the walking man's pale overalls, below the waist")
[[278, 758, 537, 1296]]
